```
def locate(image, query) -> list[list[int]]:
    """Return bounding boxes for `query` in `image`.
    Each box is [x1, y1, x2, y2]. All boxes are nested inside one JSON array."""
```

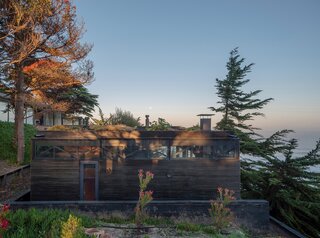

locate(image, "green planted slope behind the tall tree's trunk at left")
[[0, 121, 36, 163]]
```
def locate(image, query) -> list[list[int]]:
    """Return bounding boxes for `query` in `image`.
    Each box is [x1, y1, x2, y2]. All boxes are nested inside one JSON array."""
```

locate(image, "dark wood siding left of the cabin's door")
[[31, 160, 80, 201]]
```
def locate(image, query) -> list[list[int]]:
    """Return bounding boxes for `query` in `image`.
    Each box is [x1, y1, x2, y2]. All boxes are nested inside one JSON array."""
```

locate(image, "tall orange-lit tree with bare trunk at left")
[[0, 0, 93, 162]]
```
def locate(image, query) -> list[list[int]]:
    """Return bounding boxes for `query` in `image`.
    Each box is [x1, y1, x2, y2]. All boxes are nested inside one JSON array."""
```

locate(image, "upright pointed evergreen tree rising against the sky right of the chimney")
[[210, 48, 273, 153]]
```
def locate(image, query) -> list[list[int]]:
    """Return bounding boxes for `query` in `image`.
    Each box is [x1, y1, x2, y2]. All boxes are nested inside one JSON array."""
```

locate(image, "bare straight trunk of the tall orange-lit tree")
[[15, 67, 25, 163]]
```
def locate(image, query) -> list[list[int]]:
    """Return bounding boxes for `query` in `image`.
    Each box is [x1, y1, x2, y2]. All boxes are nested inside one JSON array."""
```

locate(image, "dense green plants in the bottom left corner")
[[4, 208, 95, 238]]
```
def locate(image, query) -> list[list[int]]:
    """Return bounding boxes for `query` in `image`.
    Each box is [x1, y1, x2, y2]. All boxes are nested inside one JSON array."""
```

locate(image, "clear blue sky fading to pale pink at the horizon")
[[74, 0, 320, 148]]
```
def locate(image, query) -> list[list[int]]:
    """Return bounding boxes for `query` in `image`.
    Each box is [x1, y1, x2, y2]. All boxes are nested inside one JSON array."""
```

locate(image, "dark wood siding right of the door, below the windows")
[[99, 159, 240, 200]]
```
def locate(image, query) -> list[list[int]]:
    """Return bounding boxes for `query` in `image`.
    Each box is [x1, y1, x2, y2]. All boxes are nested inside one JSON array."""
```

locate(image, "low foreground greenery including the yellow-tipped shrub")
[[3, 208, 246, 238]]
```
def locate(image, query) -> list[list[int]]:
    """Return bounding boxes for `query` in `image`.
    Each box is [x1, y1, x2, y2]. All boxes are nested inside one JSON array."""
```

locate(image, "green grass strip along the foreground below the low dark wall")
[[3, 208, 248, 238]]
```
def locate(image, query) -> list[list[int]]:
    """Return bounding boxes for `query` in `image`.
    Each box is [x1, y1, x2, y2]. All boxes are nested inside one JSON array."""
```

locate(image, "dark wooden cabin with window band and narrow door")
[[31, 130, 240, 201]]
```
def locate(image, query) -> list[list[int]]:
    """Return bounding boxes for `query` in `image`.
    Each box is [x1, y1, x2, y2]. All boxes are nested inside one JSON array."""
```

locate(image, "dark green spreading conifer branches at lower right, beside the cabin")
[[241, 136, 320, 237]]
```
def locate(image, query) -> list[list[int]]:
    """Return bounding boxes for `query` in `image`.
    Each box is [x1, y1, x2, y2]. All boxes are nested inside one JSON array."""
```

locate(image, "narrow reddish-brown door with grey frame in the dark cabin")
[[80, 161, 99, 201]]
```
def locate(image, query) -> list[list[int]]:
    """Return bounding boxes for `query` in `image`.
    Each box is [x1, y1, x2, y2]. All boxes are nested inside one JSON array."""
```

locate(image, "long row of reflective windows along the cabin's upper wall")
[[34, 139, 238, 160]]
